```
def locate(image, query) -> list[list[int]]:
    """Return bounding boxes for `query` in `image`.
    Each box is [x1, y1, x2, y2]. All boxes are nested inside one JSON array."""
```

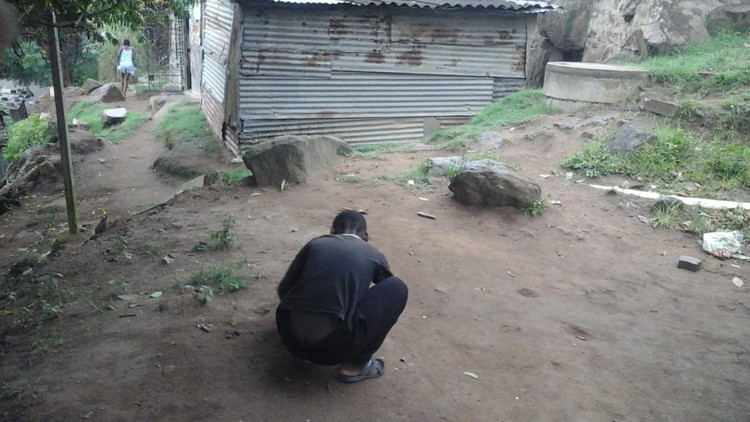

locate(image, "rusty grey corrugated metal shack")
[[201, 0, 553, 154]]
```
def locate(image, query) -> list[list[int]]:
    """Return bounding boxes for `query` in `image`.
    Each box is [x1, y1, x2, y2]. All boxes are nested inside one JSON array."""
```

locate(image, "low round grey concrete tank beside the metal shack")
[[544, 62, 648, 112]]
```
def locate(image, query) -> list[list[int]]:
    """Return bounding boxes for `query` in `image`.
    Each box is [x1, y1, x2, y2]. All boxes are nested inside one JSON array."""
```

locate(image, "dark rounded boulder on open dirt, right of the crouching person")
[[448, 160, 542, 209]]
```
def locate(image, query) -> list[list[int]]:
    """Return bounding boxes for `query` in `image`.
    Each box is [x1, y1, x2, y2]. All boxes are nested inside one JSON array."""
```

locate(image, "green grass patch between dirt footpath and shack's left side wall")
[[154, 103, 216, 152]]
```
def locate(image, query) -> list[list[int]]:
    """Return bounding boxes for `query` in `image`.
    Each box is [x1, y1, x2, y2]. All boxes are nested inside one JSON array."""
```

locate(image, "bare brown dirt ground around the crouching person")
[[0, 92, 750, 422]]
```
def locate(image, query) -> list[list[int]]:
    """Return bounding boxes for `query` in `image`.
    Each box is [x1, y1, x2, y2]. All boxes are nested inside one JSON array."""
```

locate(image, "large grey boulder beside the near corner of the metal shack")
[[242, 135, 352, 186]]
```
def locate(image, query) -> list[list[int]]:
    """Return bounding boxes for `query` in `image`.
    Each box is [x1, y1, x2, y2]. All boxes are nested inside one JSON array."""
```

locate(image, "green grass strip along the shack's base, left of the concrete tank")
[[429, 89, 551, 150]]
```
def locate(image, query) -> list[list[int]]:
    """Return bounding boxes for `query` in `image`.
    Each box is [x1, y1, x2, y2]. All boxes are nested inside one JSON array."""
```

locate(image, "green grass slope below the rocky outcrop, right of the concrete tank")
[[638, 32, 750, 94]]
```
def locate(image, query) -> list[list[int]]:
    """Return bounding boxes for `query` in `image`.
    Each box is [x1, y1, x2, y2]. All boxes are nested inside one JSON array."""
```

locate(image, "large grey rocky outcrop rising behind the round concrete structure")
[[527, 0, 750, 80]]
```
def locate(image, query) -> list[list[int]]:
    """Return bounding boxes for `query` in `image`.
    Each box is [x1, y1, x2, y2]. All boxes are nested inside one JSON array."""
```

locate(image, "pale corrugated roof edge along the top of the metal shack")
[[274, 0, 558, 13]]
